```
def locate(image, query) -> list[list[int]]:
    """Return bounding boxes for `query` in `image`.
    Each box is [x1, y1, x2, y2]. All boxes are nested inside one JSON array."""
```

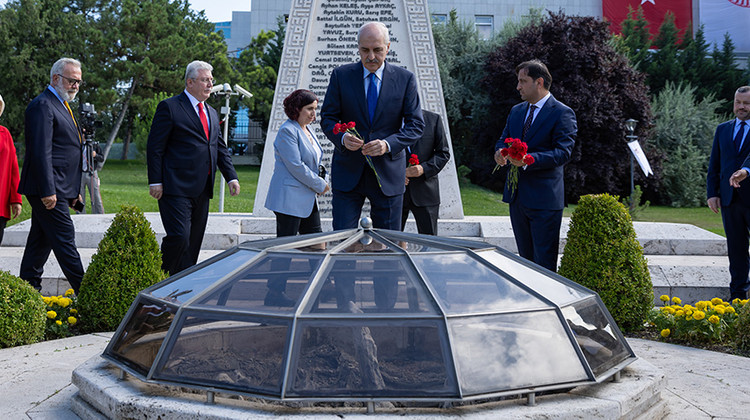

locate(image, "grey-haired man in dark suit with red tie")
[[147, 61, 240, 275]]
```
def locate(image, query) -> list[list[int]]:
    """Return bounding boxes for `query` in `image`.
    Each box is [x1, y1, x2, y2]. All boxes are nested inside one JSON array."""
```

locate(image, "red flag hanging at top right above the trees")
[[602, 0, 693, 39]]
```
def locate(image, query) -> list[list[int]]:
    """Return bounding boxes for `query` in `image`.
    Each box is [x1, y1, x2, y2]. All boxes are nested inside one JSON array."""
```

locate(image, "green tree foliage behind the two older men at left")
[[0, 0, 232, 167]]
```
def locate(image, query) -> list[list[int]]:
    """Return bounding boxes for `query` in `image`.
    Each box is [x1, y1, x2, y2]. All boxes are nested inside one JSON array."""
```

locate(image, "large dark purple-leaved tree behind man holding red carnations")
[[482, 12, 659, 202]]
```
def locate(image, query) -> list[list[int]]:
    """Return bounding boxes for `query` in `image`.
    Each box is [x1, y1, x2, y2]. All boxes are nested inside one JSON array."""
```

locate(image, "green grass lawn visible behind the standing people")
[[8, 159, 724, 236]]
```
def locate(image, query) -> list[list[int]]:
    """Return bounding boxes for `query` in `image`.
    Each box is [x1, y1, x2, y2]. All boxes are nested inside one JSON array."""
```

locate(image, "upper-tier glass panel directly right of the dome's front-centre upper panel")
[[412, 253, 549, 314]]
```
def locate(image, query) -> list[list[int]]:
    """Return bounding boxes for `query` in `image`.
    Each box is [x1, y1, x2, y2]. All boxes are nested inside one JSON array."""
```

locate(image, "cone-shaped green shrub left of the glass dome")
[[78, 206, 167, 332]]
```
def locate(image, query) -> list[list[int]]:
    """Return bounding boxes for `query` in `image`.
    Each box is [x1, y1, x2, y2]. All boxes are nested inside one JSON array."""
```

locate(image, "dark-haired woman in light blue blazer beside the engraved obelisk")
[[265, 89, 330, 306]]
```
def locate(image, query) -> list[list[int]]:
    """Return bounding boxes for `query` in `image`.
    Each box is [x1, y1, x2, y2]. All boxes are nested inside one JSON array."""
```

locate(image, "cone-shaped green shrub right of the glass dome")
[[559, 194, 654, 331]]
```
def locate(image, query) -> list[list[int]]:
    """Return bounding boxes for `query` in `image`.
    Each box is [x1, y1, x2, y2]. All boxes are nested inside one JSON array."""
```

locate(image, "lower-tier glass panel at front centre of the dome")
[[286, 320, 458, 397]]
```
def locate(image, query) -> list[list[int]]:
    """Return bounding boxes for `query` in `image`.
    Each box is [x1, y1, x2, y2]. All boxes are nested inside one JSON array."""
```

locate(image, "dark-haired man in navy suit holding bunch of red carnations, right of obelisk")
[[495, 60, 578, 271]]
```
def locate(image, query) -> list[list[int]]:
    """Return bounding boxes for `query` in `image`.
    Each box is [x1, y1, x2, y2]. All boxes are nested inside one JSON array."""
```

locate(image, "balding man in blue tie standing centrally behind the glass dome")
[[320, 22, 424, 230]]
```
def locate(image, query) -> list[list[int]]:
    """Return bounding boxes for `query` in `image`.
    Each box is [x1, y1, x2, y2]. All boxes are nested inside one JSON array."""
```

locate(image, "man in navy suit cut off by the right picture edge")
[[706, 86, 750, 300]]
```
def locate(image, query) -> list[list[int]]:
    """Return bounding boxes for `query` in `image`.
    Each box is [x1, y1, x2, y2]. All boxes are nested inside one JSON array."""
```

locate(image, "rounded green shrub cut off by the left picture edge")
[[0, 271, 46, 348]]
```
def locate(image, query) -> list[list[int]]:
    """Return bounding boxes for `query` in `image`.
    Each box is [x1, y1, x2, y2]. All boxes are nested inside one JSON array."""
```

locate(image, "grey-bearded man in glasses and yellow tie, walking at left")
[[18, 58, 83, 293]]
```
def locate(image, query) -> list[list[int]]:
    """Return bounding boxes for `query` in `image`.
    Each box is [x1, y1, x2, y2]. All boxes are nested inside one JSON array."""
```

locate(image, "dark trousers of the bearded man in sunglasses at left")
[[19, 195, 83, 293]]
